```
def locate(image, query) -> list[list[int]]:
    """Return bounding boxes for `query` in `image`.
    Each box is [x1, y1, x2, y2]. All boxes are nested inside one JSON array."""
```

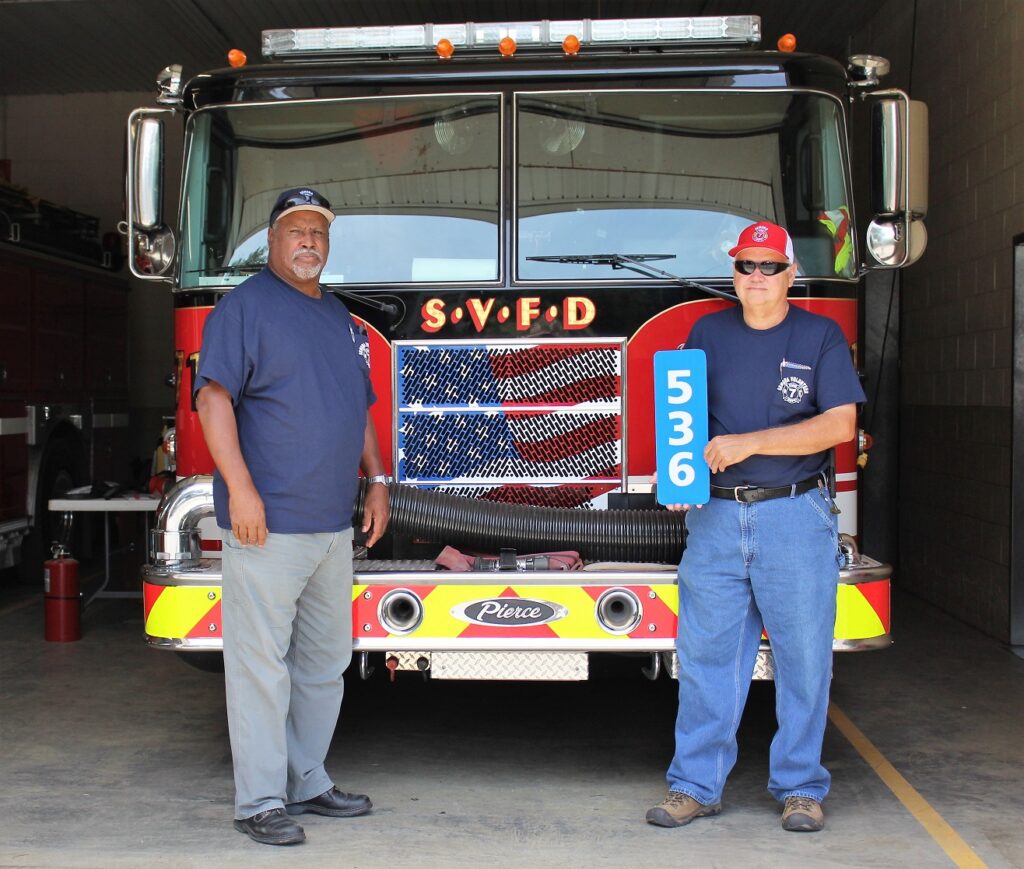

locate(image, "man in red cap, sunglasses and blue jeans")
[[647, 221, 864, 832]]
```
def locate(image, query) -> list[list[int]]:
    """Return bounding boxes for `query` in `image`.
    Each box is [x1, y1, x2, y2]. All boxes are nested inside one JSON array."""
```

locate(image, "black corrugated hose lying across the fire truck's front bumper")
[[354, 480, 686, 564]]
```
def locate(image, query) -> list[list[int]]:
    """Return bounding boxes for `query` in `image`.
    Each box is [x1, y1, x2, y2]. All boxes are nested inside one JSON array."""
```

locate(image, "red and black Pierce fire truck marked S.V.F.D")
[[127, 15, 927, 680]]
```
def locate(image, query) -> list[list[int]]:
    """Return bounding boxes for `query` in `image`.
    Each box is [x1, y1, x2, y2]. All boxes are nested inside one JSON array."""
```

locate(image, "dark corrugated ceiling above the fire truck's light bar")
[[0, 0, 883, 94]]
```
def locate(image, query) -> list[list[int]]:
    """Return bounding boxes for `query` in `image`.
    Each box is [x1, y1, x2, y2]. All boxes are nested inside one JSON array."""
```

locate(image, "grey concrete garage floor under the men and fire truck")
[[0, 569, 1024, 869]]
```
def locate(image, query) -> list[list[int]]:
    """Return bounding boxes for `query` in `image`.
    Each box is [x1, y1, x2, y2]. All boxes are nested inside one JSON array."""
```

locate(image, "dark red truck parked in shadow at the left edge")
[[0, 181, 128, 579]]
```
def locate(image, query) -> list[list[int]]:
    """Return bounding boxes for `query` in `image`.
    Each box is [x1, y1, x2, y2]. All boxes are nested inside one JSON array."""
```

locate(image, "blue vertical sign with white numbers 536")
[[654, 350, 711, 504]]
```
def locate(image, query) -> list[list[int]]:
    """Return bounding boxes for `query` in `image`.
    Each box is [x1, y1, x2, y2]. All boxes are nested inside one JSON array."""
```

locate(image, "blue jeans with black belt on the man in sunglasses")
[[668, 490, 839, 805]]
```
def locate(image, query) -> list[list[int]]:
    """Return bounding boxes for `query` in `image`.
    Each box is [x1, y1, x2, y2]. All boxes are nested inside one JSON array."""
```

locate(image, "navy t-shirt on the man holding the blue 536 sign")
[[686, 305, 864, 487]]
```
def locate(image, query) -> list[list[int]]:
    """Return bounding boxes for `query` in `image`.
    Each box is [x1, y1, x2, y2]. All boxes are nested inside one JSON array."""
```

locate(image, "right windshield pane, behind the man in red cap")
[[516, 90, 854, 281]]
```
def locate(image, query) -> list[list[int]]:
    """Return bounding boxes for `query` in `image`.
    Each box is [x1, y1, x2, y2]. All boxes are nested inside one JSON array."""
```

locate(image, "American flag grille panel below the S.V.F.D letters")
[[395, 341, 624, 491]]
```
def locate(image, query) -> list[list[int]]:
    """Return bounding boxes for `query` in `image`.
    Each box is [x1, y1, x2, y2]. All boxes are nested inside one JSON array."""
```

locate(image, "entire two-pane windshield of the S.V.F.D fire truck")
[[181, 90, 856, 288]]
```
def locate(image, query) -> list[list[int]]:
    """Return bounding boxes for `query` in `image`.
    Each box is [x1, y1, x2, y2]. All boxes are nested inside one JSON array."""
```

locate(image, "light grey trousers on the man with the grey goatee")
[[221, 528, 352, 819]]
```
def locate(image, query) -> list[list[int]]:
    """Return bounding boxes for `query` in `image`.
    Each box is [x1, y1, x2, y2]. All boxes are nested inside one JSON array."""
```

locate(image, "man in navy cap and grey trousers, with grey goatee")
[[194, 187, 388, 844]]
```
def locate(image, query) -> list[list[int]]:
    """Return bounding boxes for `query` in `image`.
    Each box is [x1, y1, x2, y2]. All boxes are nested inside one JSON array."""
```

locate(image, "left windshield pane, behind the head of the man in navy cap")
[[181, 94, 501, 288]]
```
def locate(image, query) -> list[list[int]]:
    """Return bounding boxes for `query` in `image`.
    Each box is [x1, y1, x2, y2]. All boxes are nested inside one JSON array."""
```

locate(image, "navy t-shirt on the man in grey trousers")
[[194, 268, 375, 534]]
